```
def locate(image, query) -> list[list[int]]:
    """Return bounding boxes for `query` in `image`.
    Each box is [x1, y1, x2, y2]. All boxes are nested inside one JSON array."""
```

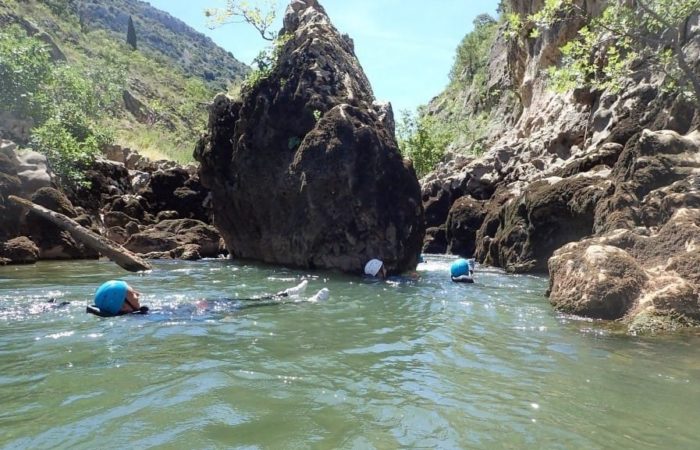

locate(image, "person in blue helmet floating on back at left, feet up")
[[86, 280, 330, 317]]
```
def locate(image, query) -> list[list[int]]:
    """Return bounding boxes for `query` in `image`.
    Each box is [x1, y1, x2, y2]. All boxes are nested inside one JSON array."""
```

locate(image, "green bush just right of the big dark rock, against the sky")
[[397, 110, 456, 178]]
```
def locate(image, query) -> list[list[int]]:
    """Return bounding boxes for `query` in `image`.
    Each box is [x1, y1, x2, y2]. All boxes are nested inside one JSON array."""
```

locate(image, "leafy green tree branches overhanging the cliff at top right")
[[509, 0, 700, 106]]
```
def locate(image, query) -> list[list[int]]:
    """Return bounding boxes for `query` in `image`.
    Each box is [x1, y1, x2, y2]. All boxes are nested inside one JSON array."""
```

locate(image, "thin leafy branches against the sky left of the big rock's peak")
[[204, 0, 277, 41]]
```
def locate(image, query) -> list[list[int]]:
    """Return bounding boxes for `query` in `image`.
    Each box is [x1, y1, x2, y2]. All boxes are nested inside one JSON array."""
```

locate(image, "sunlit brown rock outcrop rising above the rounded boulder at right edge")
[[549, 130, 700, 332]]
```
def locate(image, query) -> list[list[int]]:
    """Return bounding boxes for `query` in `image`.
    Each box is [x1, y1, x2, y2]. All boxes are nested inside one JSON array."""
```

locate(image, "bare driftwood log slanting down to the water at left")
[[8, 195, 151, 272]]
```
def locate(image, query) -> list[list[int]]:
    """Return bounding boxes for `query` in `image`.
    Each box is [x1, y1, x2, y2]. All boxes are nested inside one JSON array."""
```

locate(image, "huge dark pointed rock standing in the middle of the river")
[[200, 0, 424, 272]]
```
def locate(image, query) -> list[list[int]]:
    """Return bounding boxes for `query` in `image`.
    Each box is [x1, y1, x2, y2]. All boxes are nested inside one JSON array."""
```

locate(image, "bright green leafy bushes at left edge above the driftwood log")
[[0, 27, 123, 185]]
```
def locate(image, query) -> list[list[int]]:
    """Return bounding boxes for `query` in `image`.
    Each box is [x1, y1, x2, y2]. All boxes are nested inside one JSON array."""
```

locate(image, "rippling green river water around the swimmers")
[[0, 257, 700, 449]]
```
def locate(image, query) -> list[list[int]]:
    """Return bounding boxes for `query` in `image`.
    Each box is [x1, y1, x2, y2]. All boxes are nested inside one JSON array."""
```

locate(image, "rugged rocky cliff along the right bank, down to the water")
[[422, 0, 700, 329]]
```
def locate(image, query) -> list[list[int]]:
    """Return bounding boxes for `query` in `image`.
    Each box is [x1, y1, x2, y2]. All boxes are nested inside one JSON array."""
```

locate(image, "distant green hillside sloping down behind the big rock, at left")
[[0, 0, 249, 162]]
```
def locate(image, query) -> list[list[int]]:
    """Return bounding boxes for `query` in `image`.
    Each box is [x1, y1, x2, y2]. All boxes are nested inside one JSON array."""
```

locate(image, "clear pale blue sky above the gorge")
[[147, 0, 498, 113]]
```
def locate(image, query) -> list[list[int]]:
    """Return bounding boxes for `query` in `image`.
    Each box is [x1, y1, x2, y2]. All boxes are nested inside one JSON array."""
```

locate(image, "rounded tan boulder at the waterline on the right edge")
[[548, 208, 700, 333]]
